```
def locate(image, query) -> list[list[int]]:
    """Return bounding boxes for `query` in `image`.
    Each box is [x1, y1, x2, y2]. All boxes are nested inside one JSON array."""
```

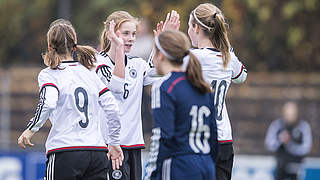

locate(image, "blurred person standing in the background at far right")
[[265, 102, 312, 180]]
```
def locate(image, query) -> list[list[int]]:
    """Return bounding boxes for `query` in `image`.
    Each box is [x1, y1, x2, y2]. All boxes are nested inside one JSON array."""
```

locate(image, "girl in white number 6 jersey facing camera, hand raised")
[[95, 11, 179, 180]]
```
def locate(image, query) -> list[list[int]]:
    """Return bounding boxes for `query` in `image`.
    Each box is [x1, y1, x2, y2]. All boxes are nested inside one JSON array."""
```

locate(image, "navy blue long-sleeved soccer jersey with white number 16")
[[145, 72, 218, 179]]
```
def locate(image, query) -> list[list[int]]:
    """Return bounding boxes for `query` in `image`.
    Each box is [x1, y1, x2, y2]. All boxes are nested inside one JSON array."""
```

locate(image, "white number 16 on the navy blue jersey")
[[189, 105, 211, 154]]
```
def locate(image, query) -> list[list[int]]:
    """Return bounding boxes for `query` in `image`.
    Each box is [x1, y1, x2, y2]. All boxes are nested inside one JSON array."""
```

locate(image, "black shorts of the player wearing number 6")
[[109, 149, 142, 180]]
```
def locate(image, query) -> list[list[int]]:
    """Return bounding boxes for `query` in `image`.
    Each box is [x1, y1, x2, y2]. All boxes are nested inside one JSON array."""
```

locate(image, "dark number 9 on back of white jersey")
[[74, 87, 89, 128]]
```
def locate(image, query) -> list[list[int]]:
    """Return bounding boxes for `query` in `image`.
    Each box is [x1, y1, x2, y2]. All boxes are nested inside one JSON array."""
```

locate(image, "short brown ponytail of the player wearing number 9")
[[74, 45, 97, 69]]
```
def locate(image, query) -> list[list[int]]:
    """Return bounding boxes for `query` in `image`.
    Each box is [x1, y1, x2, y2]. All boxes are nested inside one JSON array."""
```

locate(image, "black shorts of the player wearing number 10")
[[216, 143, 234, 180]]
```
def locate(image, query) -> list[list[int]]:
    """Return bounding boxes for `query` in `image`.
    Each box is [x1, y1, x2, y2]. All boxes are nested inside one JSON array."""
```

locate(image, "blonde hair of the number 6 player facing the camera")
[[100, 11, 138, 52]]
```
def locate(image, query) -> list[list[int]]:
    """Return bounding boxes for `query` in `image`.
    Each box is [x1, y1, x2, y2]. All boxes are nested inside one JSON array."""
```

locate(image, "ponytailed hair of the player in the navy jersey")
[[156, 30, 211, 94]]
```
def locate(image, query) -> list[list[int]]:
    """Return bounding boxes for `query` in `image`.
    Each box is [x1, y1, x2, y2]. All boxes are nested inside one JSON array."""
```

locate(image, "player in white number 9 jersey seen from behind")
[[18, 20, 123, 180]]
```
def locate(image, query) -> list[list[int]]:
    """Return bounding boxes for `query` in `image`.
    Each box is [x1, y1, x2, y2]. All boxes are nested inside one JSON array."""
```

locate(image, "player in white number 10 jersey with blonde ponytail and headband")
[[186, 3, 247, 180]]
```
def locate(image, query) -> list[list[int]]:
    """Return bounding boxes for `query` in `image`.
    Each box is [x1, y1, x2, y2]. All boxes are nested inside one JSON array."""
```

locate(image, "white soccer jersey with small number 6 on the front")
[[95, 52, 156, 148]]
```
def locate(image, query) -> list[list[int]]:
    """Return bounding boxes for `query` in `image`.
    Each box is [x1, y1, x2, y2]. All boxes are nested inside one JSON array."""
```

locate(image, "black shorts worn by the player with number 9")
[[45, 151, 108, 180]]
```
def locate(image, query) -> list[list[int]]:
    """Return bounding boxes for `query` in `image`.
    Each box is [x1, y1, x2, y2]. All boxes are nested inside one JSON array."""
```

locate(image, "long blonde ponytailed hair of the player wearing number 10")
[[191, 3, 230, 67]]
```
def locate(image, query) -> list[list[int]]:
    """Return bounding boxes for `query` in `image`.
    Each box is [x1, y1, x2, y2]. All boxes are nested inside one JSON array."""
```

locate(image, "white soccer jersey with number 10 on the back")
[[191, 48, 247, 143]]
